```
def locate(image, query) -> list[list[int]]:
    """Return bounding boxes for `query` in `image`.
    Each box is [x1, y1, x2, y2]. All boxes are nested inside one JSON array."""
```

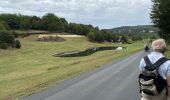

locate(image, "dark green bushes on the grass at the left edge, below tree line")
[[0, 31, 21, 49]]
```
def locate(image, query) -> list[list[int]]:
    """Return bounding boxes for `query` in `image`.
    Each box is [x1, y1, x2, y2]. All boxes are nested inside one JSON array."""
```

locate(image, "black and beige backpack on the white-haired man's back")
[[139, 56, 168, 96]]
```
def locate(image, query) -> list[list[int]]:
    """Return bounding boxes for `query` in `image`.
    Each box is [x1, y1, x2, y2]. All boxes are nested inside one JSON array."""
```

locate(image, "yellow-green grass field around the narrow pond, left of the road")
[[0, 34, 143, 100]]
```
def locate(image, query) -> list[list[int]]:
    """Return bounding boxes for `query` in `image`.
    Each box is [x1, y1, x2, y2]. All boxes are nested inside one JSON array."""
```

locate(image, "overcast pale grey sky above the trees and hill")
[[0, 0, 151, 28]]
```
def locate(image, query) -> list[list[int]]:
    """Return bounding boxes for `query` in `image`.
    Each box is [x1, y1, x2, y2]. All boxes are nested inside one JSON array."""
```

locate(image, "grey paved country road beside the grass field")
[[22, 52, 145, 100]]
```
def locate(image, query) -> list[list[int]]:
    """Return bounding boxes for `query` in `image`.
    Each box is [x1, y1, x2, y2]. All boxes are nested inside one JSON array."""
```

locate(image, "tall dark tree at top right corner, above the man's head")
[[151, 0, 170, 42]]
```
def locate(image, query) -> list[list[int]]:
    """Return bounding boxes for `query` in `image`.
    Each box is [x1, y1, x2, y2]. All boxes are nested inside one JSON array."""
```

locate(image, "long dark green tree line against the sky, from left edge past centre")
[[0, 13, 131, 42]]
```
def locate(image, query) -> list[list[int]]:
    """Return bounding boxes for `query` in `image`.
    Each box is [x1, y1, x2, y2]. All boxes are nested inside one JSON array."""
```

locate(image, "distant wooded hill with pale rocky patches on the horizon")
[[105, 25, 158, 33]]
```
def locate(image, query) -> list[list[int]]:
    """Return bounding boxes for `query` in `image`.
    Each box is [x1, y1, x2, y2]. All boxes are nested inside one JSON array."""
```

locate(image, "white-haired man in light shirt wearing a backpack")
[[139, 39, 170, 100]]
